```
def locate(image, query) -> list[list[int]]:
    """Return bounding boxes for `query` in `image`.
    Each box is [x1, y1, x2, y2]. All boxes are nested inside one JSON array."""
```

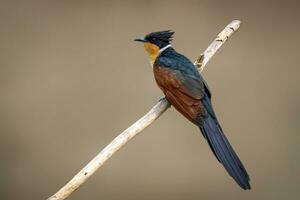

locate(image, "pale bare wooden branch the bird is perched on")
[[48, 20, 241, 200]]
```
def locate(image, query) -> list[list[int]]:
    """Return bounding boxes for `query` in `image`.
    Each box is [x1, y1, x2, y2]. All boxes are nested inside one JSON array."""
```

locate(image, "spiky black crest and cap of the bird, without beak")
[[145, 30, 175, 47]]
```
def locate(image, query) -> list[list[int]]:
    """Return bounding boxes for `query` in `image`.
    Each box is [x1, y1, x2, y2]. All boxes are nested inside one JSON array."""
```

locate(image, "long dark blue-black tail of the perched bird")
[[199, 97, 251, 190]]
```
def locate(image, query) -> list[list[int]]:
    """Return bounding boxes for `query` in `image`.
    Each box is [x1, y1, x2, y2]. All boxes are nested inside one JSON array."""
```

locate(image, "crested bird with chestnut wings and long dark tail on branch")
[[134, 30, 251, 190]]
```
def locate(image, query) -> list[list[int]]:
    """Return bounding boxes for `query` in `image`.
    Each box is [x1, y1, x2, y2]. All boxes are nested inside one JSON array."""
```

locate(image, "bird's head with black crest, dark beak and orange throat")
[[134, 30, 174, 64]]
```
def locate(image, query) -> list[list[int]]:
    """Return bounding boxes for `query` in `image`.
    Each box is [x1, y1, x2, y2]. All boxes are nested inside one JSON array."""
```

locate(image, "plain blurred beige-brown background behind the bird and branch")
[[0, 0, 300, 200]]
